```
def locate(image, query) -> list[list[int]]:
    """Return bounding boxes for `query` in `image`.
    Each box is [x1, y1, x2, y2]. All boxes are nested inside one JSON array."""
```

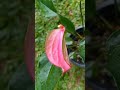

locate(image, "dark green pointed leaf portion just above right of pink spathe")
[[59, 14, 76, 35]]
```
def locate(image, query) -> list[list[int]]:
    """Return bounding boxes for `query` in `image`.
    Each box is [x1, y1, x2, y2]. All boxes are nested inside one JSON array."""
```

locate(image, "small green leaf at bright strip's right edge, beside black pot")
[[79, 40, 85, 62]]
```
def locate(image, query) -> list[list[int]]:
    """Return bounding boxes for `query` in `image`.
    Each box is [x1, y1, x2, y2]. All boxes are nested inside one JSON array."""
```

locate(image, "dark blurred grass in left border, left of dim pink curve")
[[0, 0, 34, 90]]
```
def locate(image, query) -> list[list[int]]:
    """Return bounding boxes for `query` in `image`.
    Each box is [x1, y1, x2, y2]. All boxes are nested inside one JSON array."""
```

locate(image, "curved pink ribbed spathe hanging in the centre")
[[45, 25, 71, 73]]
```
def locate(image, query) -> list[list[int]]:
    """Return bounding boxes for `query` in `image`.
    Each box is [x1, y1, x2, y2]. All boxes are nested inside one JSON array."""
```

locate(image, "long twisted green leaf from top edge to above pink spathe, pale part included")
[[38, 0, 76, 35]]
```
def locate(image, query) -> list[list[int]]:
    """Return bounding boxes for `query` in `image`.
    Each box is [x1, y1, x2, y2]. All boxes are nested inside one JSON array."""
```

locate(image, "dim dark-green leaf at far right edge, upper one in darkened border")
[[106, 30, 120, 51]]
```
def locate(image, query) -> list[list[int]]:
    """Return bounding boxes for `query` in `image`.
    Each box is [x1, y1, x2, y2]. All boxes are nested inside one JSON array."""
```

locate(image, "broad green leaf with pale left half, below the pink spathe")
[[36, 54, 62, 90]]
